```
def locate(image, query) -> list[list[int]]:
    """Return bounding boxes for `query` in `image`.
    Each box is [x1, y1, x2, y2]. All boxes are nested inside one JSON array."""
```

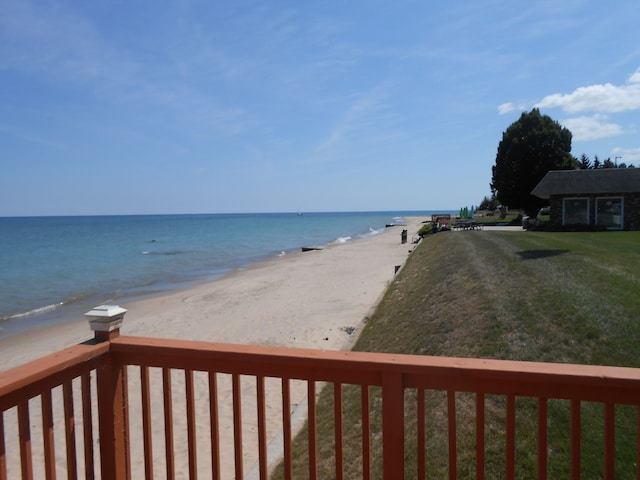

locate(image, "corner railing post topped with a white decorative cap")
[[85, 305, 131, 480]]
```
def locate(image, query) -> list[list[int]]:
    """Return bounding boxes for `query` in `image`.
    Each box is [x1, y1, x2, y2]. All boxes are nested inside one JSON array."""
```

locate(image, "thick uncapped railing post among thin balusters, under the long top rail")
[[382, 372, 404, 479]]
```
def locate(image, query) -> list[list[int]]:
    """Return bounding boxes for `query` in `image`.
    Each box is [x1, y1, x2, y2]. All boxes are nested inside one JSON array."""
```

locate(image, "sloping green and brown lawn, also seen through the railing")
[[276, 231, 640, 479]]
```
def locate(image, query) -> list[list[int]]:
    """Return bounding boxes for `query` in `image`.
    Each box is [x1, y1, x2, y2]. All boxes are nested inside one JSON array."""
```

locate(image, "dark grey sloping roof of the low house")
[[531, 168, 640, 199]]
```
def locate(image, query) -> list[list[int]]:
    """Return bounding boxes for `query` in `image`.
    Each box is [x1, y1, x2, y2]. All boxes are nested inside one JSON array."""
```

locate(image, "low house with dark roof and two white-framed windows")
[[531, 168, 640, 230]]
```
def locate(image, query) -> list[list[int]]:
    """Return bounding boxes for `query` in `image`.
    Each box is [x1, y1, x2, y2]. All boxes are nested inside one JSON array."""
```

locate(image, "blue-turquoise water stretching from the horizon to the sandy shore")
[[0, 212, 451, 336]]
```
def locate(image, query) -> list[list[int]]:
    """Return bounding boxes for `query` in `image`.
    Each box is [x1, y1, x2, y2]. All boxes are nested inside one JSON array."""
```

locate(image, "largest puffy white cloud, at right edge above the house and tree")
[[536, 69, 640, 113]]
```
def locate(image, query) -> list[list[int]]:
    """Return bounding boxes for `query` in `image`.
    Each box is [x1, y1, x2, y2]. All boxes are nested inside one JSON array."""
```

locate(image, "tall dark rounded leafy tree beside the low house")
[[491, 108, 578, 215]]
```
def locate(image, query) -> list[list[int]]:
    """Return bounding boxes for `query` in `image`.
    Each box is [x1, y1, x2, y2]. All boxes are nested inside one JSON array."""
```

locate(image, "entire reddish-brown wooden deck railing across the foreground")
[[0, 316, 640, 479]]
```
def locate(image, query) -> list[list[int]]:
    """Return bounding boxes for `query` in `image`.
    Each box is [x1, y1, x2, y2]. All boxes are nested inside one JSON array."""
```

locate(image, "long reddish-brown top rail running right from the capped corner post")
[[111, 337, 640, 405]]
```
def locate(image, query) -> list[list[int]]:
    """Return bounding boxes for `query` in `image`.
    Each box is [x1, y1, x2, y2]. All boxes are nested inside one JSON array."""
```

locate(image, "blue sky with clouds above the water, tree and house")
[[0, 0, 640, 216]]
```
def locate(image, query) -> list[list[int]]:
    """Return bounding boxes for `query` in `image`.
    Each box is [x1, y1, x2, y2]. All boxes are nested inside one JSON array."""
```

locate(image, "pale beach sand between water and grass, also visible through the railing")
[[0, 217, 423, 477]]
